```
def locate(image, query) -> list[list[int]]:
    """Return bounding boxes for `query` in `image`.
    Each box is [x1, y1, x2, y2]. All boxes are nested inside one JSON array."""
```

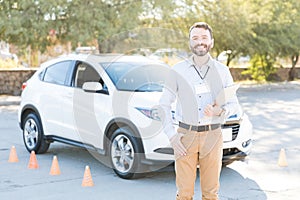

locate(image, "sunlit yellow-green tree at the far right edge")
[[249, 0, 300, 80]]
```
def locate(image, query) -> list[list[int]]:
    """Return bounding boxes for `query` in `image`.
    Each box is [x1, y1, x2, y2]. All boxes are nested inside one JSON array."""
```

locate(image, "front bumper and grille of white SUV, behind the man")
[[139, 112, 253, 165]]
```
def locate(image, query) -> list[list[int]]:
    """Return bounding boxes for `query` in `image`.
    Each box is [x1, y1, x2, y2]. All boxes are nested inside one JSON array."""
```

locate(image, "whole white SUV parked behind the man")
[[18, 54, 252, 179]]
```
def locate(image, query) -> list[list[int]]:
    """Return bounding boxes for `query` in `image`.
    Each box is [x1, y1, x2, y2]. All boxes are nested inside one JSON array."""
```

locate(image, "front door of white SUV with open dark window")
[[62, 61, 109, 148]]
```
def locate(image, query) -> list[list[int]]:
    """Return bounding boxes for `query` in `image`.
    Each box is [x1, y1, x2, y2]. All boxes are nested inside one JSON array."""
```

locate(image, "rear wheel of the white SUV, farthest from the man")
[[23, 113, 50, 153]]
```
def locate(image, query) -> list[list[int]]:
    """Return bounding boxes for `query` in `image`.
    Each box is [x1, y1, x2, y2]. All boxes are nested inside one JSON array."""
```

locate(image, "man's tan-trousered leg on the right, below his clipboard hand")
[[199, 129, 223, 200]]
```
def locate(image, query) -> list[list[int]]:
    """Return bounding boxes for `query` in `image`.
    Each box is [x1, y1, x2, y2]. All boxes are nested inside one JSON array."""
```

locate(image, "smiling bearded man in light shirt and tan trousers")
[[160, 22, 239, 200]]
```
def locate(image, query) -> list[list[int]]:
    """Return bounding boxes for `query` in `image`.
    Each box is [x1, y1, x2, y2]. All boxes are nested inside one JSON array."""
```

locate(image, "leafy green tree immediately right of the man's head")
[[198, 0, 251, 66]]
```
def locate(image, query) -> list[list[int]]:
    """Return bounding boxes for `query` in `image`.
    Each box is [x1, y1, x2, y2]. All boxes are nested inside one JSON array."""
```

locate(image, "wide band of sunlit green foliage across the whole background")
[[0, 0, 300, 80]]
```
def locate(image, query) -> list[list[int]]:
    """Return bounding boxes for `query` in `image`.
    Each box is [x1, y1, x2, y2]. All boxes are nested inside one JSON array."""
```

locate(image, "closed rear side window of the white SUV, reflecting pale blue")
[[43, 61, 71, 85]]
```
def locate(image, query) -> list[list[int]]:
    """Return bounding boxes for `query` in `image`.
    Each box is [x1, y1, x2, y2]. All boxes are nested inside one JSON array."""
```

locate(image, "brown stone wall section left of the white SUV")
[[0, 69, 36, 96]]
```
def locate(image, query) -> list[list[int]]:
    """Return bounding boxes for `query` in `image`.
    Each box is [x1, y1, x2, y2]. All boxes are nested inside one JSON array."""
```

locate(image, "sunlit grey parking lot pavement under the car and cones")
[[0, 82, 300, 200]]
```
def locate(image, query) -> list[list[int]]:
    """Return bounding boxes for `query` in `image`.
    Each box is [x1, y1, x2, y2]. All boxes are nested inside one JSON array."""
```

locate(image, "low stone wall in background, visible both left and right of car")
[[0, 68, 300, 95]]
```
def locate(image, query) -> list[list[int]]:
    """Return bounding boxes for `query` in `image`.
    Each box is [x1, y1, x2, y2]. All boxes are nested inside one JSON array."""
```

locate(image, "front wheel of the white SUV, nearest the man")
[[109, 127, 144, 179]]
